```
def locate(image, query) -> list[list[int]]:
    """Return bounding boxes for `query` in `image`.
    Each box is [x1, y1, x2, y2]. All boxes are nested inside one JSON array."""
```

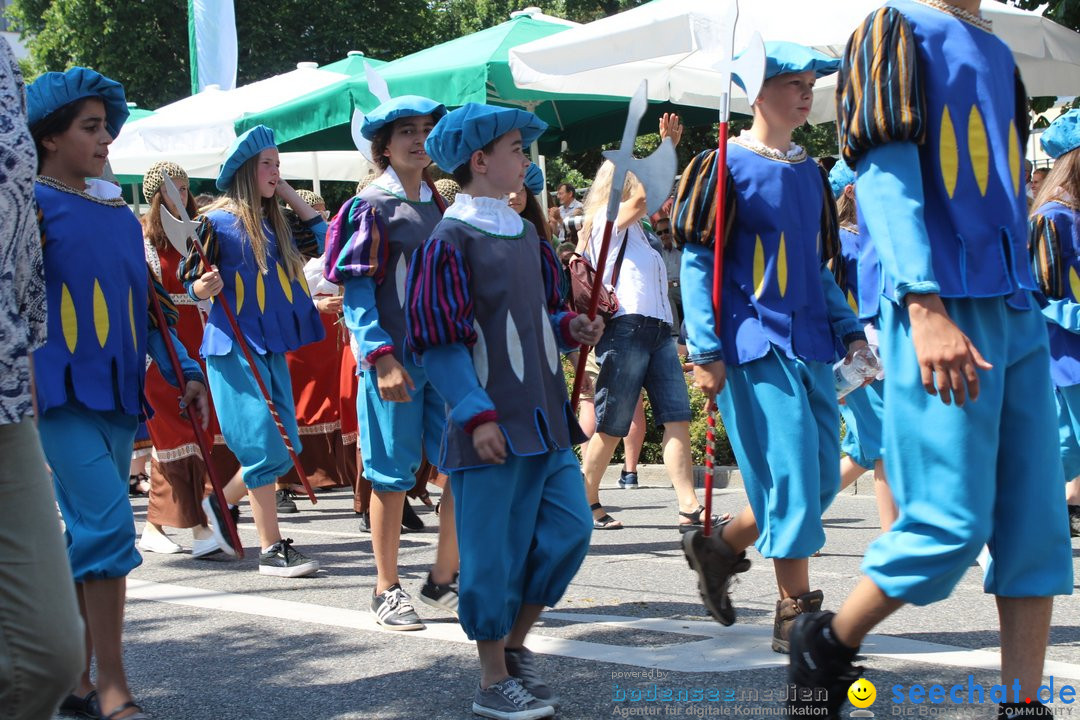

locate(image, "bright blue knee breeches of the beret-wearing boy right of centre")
[[716, 345, 840, 559]]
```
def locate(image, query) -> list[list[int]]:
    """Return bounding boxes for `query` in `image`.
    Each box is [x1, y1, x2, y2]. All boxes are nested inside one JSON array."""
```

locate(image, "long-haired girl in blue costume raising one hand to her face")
[[180, 125, 326, 578]]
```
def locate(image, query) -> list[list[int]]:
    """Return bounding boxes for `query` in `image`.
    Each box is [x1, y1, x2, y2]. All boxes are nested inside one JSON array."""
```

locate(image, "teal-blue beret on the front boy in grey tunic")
[[423, 103, 548, 173]]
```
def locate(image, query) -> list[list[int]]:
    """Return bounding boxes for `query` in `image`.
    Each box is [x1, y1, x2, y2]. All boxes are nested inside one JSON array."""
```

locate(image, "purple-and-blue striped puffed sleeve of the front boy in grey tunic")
[[405, 237, 476, 353]]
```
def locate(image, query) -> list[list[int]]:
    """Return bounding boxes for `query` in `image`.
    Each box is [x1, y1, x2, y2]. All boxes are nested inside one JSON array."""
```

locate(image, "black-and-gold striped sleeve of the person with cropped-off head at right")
[[836, 8, 927, 167]]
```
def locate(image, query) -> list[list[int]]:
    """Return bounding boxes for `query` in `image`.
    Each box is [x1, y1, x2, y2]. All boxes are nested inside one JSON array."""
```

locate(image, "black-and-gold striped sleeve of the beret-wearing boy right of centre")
[[672, 150, 735, 247]]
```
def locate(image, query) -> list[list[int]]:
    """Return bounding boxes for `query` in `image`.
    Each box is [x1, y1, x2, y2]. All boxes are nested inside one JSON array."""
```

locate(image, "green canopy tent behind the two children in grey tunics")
[[235, 11, 716, 158]]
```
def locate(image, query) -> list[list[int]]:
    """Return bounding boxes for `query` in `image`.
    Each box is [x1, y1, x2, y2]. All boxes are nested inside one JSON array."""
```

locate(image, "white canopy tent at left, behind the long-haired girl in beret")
[[109, 63, 373, 191]]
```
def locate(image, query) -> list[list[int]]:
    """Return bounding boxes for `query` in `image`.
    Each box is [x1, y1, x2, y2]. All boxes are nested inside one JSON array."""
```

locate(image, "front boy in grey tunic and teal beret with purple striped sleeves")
[[407, 104, 604, 720]]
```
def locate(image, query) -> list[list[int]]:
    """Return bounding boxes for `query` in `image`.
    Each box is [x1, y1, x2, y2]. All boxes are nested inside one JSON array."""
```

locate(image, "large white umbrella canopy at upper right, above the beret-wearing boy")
[[510, 0, 1080, 123]]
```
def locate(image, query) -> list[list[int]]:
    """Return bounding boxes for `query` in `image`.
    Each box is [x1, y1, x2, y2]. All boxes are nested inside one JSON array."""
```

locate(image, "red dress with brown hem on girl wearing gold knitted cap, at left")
[[145, 240, 240, 528]]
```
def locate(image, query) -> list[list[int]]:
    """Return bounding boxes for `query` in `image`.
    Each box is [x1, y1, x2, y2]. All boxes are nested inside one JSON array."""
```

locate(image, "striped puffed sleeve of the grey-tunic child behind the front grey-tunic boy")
[[323, 198, 390, 283]]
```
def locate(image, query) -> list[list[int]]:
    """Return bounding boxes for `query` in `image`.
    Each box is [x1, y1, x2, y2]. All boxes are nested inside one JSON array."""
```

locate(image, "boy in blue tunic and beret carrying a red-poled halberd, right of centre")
[[673, 43, 866, 652]]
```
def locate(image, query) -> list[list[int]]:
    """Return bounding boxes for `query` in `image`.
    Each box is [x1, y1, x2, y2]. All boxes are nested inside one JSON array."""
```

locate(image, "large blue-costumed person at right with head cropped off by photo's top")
[[788, 0, 1072, 718]]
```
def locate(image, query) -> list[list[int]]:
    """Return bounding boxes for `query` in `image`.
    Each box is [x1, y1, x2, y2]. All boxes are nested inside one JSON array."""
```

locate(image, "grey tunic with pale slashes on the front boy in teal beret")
[[432, 219, 588, 470]]
